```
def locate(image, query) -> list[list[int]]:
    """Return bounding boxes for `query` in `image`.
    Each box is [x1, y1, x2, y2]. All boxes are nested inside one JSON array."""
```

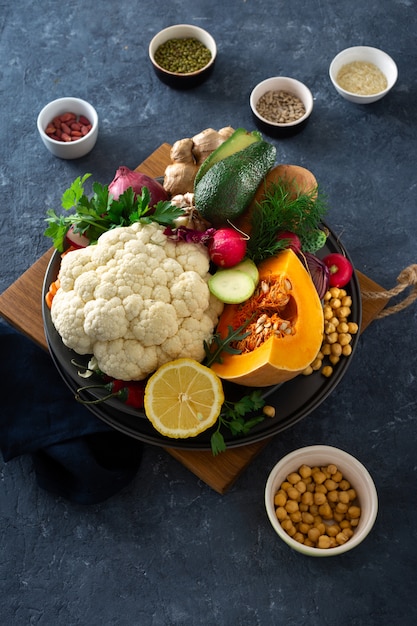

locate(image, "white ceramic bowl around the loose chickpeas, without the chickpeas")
[[265, 445, 378, 557]]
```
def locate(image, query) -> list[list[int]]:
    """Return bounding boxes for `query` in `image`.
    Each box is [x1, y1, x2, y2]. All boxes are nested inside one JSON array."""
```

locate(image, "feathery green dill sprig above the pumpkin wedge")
[[247, 181, 328, 264]]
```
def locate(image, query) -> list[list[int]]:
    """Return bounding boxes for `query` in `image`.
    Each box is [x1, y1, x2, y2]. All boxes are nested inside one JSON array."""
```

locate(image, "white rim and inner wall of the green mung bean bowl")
[[149, 24, 217, 78]]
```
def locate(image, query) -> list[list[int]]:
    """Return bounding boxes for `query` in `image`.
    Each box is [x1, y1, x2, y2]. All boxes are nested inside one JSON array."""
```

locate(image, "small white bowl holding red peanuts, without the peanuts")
[[37, 98, 98, 159]]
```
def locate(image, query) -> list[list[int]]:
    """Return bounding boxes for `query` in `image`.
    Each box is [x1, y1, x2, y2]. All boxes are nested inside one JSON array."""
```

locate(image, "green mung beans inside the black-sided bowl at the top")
[[155, 38, 211, 74]]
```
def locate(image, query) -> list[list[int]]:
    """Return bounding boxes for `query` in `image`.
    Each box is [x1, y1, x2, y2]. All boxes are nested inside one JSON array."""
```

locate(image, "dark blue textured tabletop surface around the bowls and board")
[[0, 0, 417, 626]]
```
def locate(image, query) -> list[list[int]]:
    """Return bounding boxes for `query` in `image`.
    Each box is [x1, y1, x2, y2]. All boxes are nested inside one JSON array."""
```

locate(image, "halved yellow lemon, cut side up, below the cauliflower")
[[144, 359, 224, 439]]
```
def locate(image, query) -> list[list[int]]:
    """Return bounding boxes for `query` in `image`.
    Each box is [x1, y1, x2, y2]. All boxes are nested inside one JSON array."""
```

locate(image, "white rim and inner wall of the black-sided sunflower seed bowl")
[[249, 76, 313, 129]]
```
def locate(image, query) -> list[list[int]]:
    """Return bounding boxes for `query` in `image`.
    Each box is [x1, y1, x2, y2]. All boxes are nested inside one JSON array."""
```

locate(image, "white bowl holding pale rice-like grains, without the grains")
[[329, 46, 398, 104]]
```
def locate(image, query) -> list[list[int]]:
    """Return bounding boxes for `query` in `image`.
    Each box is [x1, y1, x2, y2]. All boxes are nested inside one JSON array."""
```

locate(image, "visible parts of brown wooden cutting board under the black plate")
[[0, 143, 387, 494]]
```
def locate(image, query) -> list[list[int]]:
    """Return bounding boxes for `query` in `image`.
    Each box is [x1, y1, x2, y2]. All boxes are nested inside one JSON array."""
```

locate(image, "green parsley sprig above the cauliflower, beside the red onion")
[[44, 174, 183, 252]]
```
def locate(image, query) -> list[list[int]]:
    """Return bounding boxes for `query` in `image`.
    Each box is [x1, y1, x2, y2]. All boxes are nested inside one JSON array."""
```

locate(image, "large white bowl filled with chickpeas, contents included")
[[265, 445, 378, 556]]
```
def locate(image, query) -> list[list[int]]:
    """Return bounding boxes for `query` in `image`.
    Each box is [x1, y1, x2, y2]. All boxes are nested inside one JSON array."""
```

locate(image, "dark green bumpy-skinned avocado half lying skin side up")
[[194, 140, 276, 228]]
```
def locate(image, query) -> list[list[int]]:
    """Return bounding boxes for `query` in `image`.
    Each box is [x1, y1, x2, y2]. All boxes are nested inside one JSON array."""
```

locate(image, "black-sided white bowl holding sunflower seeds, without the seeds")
[[249, 76, 313, 137]]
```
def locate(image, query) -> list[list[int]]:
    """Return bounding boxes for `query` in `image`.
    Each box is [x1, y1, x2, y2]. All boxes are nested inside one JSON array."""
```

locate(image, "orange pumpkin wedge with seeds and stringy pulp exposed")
[[211, 249, 324, 387]]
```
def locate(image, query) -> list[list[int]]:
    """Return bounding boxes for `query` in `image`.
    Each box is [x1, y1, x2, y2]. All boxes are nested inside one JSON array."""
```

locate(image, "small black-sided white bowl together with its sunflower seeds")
[[250, 76, 313, 137]]
